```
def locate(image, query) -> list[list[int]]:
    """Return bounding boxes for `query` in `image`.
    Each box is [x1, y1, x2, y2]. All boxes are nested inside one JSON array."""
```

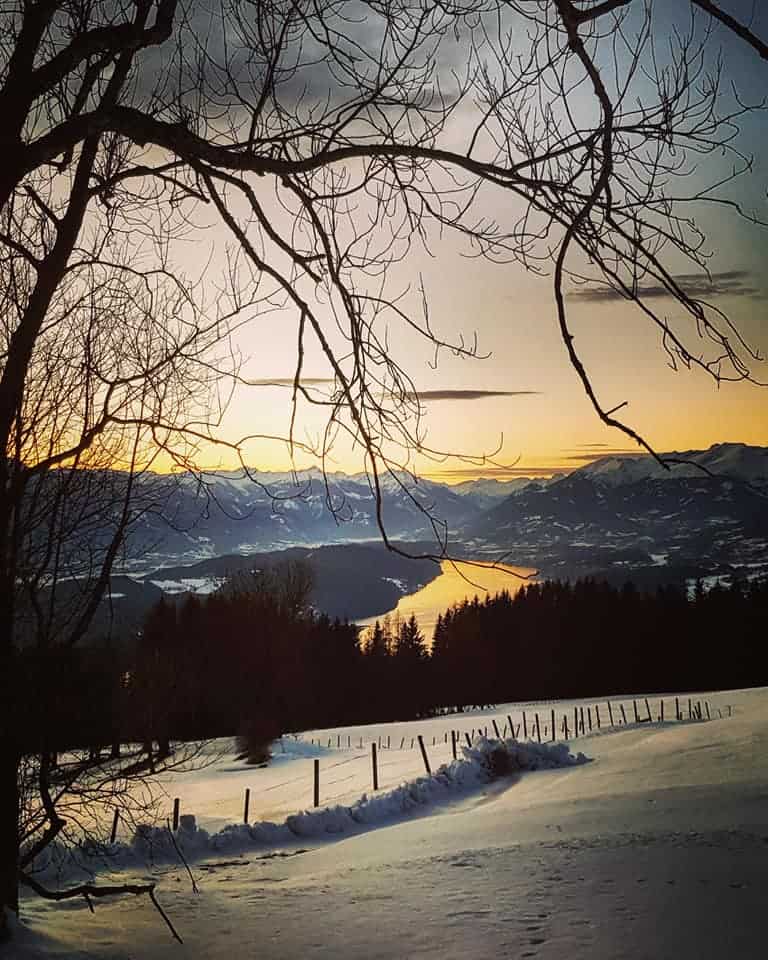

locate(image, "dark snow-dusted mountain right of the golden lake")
[[463, 444, 768, 580]]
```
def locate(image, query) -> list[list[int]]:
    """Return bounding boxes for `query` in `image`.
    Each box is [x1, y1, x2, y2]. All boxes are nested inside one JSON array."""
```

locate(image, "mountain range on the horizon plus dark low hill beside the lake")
[[66, 443, 768, 636]]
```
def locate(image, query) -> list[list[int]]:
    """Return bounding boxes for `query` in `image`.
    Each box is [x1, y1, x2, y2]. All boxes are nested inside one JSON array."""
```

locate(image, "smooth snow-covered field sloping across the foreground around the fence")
[[9, 689, 768, 960]]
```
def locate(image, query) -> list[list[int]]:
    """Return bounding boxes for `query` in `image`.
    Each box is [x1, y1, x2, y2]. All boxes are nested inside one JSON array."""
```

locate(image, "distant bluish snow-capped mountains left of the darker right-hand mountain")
[[118, 470, 484, 571]]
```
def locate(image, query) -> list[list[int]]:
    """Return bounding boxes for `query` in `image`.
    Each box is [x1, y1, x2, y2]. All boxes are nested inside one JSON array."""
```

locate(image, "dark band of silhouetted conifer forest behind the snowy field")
[[18, 572, 768, 760]]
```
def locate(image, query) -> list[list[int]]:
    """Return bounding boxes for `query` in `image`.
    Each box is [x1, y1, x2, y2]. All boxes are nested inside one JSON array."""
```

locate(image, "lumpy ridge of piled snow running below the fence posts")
[[25, 737, 589, 880]]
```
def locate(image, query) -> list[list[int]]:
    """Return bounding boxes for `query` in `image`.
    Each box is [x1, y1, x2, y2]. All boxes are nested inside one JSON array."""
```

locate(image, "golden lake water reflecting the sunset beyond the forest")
[[358, 560, 535, 644]]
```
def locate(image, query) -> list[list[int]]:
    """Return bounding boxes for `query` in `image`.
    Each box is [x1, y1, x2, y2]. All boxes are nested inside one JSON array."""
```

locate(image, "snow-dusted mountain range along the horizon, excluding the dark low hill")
[[127, 443, 768, 572]]
